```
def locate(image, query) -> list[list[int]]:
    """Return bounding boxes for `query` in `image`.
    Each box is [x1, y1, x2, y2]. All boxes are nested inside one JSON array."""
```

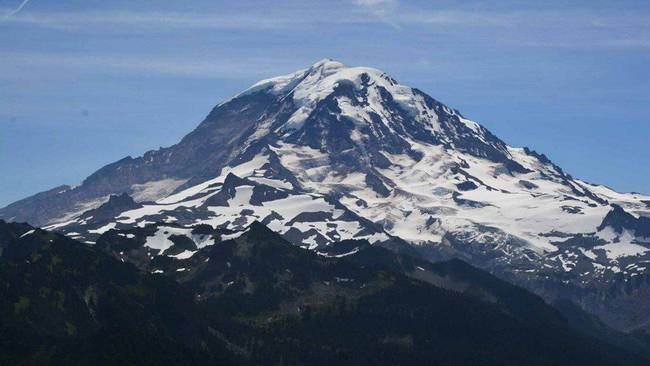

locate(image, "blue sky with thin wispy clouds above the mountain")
[[0, 0, 650, 206]]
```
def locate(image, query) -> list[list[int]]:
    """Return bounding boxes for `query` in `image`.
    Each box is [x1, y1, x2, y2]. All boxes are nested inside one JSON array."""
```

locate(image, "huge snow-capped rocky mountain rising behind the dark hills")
[[0, 60, 650, 329]]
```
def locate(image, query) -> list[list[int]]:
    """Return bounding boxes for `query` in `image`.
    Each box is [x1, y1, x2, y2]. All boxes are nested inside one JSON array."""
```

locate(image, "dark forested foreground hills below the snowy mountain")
[[0, 222, 648, 365]]
